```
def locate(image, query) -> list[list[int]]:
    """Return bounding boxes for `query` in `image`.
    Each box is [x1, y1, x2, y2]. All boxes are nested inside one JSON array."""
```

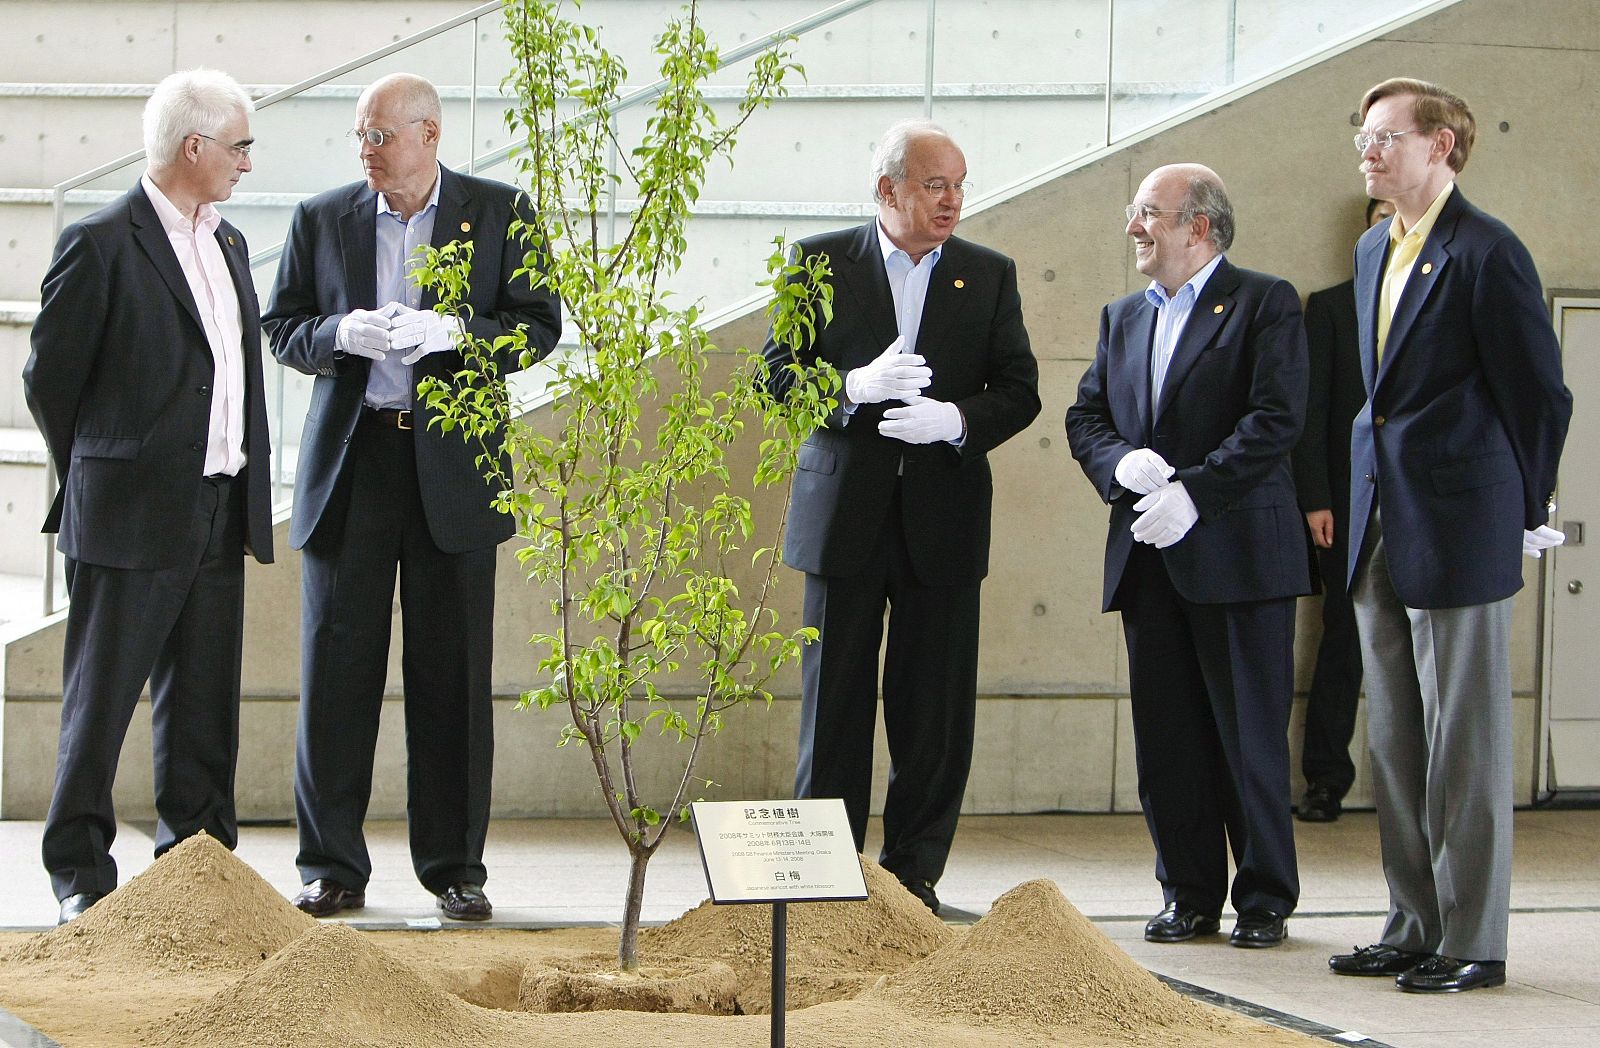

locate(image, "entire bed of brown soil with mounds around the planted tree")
[[0, 840, 1317, 1048]]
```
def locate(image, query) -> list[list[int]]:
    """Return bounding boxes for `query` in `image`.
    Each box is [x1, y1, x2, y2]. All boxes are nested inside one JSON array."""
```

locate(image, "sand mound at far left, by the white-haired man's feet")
[[14, 834, 317, 971]]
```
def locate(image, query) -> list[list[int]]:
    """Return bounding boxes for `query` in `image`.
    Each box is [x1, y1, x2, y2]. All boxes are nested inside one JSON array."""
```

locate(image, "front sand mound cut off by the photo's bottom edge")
[[142, 923, 507, 1048]]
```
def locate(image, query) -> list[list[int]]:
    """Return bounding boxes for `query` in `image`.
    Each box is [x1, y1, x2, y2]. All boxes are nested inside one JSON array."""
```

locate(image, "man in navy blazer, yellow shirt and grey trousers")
[[1328, 78, 1573, 992]]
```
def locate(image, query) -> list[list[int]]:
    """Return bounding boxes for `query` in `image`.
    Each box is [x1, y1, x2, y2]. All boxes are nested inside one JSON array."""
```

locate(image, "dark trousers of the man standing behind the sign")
[[795, 486, 979, 882]]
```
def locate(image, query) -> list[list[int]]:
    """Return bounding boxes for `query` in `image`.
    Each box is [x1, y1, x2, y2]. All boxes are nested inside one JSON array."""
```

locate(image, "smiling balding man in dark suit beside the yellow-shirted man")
[[1067, 165, 1310, 947]]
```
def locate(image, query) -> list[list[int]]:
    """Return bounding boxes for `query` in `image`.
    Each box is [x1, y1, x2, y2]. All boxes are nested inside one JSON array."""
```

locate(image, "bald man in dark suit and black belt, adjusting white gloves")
[[266, 74, 560, 920]]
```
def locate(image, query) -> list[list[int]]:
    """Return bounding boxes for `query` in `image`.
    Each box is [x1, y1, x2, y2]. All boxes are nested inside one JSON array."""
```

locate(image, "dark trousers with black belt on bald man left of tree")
[[294, 416, 494, 893]]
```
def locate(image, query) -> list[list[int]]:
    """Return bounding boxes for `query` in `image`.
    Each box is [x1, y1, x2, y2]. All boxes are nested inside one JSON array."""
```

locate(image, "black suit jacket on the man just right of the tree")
[[765, 219, 1040, 586]]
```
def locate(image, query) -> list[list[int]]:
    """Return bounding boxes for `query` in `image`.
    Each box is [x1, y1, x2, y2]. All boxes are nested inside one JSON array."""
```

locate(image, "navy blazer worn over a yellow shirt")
[[1349, 187, 1573, 608]]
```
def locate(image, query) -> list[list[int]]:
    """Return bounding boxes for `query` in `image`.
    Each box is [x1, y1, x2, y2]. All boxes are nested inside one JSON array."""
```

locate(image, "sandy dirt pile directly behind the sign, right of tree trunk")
[[640, 858, 954, 1014]]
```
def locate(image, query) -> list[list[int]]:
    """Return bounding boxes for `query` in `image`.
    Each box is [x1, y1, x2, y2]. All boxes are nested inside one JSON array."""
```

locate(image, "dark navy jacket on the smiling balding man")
[[1066, 258, 1310, 611]]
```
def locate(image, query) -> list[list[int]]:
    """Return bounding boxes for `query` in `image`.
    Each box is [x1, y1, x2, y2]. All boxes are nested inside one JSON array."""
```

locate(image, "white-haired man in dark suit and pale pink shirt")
[[22, 69, 272, 923]]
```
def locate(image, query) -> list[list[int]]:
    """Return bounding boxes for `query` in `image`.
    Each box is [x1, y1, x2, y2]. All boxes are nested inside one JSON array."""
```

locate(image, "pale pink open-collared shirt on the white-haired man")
[[139, 173, 245, 477]]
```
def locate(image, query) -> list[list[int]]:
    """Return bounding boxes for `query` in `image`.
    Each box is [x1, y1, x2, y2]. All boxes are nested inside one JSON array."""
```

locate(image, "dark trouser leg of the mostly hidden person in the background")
[[1301, 540, 1362, 800]]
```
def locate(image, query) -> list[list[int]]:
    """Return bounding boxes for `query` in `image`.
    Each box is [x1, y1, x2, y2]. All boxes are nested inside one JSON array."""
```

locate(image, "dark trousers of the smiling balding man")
[[1118, 544, 1299, 915]]
